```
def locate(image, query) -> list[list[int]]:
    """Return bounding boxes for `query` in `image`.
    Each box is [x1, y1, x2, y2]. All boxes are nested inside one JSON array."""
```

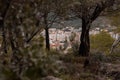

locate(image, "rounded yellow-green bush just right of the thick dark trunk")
[[90, 31, 114, 52]]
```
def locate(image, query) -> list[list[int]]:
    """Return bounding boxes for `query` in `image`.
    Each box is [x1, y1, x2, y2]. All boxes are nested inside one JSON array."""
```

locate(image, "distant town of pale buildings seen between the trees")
[[42, 26, 119, 49]]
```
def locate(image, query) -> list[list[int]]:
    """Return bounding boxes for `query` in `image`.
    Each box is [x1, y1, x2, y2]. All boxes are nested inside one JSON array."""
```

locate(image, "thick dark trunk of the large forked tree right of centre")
[[79, 19, 90, 56]]
